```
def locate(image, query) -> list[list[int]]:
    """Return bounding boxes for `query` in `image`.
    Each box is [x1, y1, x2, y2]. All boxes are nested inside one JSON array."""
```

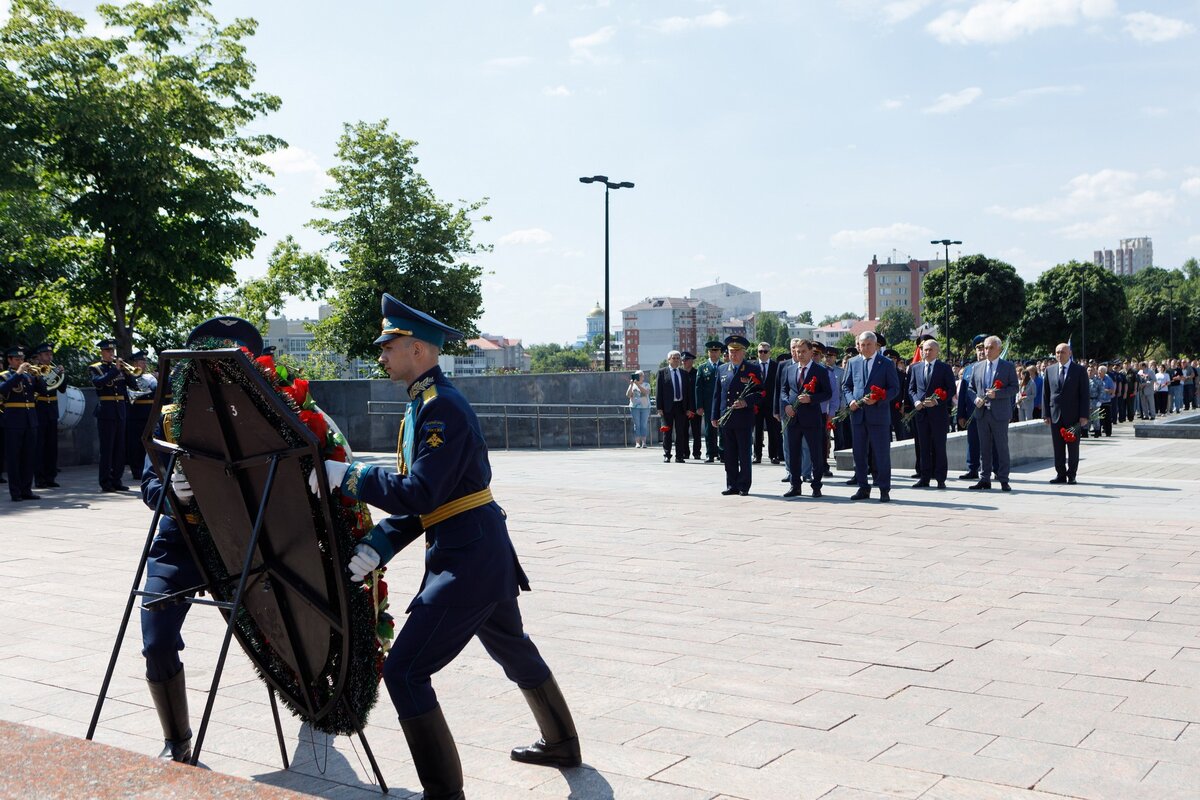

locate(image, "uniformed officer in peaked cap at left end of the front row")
[[712, 335, 767, 495]]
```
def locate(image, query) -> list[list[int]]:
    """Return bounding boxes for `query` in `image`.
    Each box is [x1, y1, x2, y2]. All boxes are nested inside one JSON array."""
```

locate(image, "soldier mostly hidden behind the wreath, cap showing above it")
[[142, 317, 263, 762]]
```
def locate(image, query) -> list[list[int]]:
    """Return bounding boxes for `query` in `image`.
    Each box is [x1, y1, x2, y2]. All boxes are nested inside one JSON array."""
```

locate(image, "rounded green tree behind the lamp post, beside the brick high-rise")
[[922, 254, 1025, 359]]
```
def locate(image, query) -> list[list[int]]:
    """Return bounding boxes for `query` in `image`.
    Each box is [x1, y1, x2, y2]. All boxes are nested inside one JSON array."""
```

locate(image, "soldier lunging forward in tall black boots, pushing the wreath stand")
[[310, 294, 581, 800]]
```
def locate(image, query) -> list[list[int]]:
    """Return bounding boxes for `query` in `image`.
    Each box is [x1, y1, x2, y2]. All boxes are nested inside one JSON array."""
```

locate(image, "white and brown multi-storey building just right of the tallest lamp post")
[[622, 293, 724, 369]]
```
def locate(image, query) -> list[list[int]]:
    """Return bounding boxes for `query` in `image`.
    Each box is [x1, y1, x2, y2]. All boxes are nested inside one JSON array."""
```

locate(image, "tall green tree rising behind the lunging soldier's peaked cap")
[[310, 120, 491, 357]]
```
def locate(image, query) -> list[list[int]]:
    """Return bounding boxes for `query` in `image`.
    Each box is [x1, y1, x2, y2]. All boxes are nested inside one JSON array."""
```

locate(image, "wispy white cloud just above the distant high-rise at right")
[[988, 169, 1186, 239]]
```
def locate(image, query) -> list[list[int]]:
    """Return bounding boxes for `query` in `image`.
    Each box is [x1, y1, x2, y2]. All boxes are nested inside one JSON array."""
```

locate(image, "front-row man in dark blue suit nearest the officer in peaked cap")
[[779, 339, 833, 498]]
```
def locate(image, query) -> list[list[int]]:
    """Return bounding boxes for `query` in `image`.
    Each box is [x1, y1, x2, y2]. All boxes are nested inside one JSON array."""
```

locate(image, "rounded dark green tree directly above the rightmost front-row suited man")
[[1016, 260, 1129, 359]]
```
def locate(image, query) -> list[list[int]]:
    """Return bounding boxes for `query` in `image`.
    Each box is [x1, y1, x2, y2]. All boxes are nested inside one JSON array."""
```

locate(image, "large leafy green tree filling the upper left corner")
[[0, 0, 283, 353]]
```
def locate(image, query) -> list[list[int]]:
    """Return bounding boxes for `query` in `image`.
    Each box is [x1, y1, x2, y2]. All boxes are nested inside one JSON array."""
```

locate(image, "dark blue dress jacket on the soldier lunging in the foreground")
[[341, 367, 529, 609]]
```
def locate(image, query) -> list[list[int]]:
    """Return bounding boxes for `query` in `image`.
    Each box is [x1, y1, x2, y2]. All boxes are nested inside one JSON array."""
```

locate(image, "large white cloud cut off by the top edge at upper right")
[[925, 0, 1117, 44]]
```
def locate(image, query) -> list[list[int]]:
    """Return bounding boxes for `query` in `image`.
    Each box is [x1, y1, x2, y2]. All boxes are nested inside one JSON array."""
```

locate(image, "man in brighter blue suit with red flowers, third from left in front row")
[[841, 331, 900, 503]]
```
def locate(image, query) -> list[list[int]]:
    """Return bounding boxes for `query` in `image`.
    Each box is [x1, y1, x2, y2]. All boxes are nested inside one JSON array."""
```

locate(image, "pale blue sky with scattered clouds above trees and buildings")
[[32, 0, 1200, 344]]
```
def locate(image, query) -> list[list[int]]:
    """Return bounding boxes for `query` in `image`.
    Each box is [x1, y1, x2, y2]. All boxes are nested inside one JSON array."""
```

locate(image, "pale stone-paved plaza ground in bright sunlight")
[[0, 428, 1200, 800]]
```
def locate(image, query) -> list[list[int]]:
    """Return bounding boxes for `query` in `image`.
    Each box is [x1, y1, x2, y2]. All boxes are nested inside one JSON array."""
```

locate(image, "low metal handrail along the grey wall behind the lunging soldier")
[[367, 401, 656, 450]]
